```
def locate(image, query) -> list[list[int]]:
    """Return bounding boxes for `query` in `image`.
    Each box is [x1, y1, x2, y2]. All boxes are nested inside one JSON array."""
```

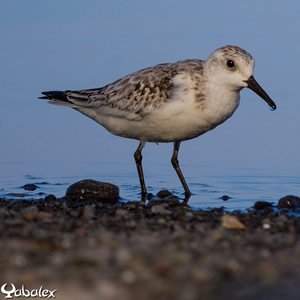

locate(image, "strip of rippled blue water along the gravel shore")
[[0, 162, 300, 210]]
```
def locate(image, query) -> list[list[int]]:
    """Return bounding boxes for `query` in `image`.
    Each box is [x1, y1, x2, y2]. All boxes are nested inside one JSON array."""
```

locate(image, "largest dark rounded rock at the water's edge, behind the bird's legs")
[[66, 179, 119, 203]]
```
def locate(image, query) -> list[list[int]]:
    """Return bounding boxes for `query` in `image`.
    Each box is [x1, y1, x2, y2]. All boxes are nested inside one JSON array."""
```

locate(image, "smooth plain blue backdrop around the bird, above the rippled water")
[[0, 0, 300, 180]]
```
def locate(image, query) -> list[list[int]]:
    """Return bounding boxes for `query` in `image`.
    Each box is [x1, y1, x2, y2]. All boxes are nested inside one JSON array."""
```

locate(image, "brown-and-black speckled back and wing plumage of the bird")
[[54, 60, 203, 120]]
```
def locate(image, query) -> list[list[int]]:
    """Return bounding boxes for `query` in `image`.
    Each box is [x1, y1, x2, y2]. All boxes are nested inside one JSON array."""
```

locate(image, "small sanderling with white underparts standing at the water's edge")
[[40, 46, 276, 202]]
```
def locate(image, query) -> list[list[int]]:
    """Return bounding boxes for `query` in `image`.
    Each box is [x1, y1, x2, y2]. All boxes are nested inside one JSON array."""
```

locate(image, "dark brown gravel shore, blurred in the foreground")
[[0, 195, 300, 300]]
